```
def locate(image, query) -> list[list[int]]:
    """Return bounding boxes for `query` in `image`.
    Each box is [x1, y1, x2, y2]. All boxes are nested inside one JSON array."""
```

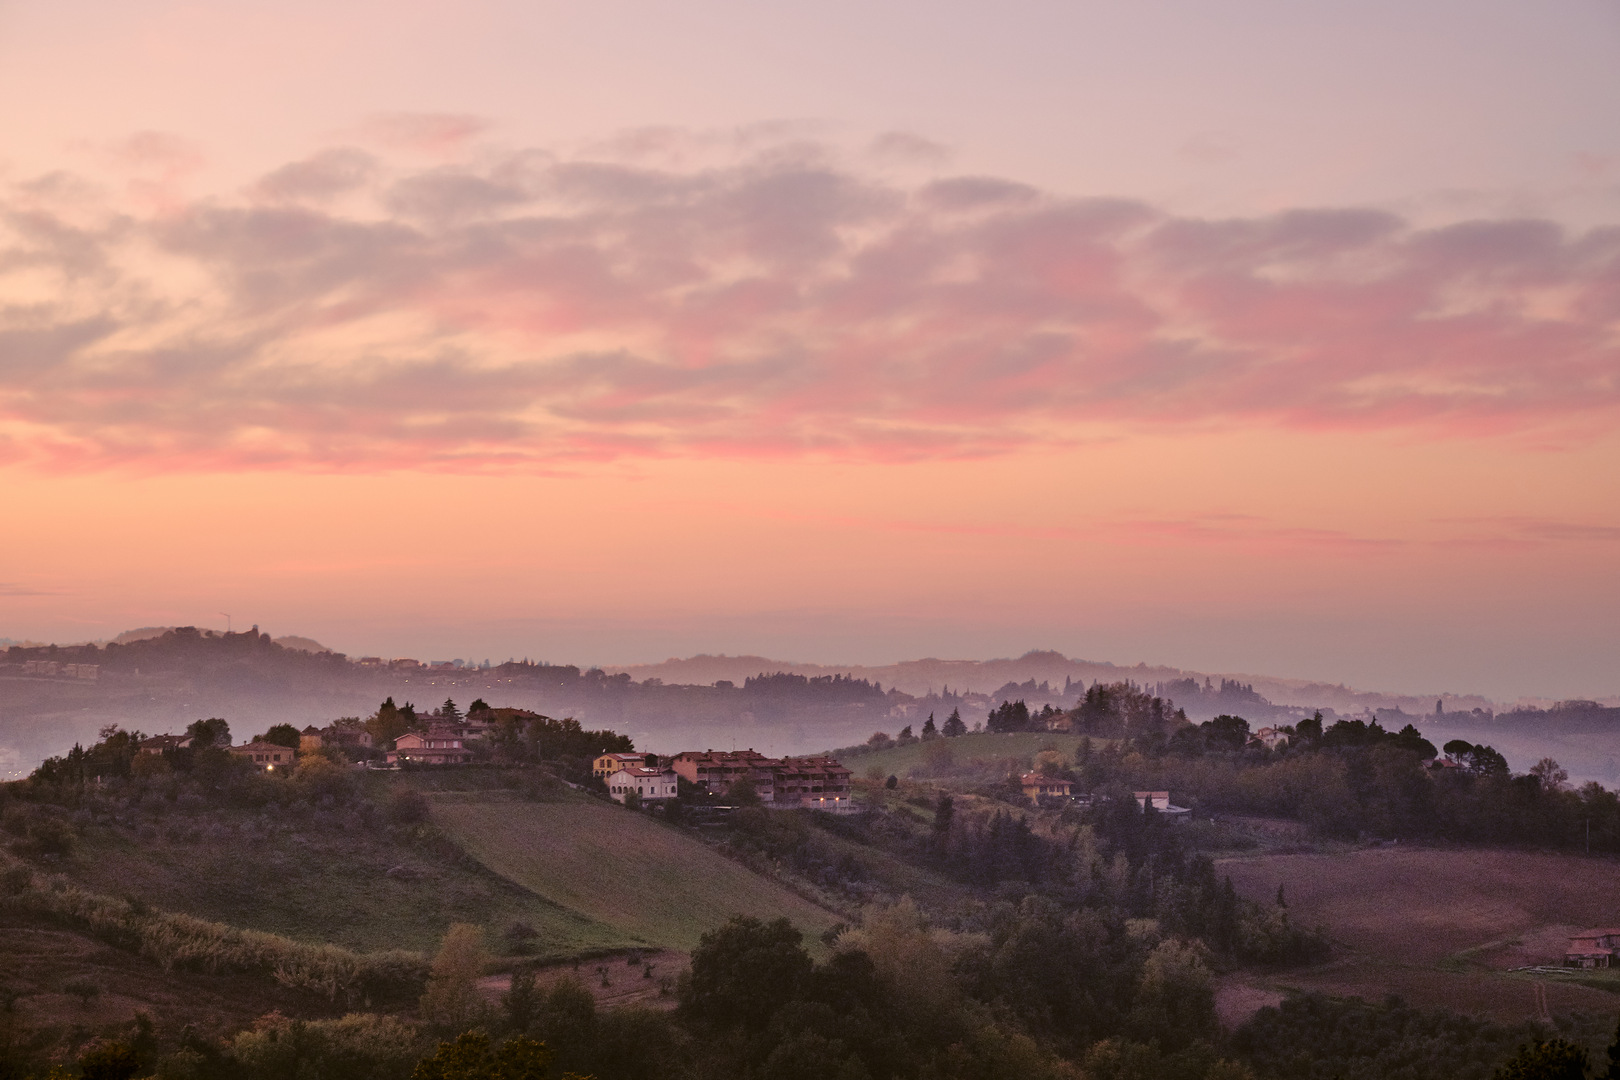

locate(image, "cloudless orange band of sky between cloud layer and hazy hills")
[[0, 420, 1620, 693]]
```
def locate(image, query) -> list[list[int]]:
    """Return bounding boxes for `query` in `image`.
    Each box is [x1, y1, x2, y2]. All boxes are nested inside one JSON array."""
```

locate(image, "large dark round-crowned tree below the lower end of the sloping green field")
[[680, 915, 812, 1031]]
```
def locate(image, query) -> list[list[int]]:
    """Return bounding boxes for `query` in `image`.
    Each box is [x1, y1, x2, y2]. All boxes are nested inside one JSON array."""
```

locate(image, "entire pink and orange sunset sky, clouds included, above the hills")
[[0, 0, 1620, 699]]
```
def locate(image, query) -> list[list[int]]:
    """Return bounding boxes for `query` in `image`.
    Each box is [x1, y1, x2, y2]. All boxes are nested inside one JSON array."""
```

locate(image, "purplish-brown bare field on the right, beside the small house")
[[1217, 845, 1620, 1020]]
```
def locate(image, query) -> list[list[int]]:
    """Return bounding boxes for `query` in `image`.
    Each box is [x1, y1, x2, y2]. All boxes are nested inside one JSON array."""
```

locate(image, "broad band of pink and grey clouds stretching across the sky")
[[0, 135, 1620, 472]]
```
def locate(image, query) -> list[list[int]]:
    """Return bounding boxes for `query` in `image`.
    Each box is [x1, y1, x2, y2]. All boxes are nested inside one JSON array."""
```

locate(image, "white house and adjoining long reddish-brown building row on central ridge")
[[591, 748, 854, 813]]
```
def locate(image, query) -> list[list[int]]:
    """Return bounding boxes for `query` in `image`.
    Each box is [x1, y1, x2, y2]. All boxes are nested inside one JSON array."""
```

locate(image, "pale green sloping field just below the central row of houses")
[[431, 792, 839, 952]]
